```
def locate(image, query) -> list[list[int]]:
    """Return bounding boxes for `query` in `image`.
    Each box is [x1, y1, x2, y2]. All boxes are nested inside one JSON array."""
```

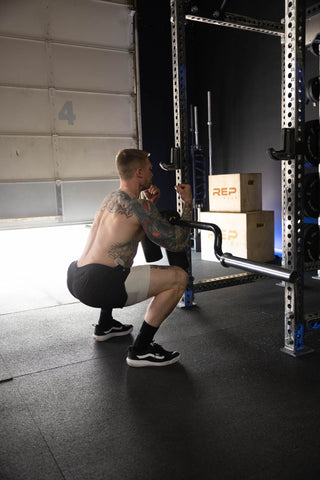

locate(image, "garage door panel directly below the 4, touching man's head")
[[58, 137, 136, 179]]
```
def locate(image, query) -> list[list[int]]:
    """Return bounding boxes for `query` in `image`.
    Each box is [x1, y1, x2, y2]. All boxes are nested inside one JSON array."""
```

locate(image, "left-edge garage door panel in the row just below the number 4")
[[0, 136, 55, 181]]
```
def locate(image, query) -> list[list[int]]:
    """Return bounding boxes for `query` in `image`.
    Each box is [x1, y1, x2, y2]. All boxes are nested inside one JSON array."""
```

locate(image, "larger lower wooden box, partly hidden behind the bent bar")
[[199, 211, 274, 262]]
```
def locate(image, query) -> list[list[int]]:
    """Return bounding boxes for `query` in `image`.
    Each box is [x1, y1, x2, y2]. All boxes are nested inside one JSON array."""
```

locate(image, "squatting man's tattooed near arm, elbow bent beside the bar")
[[132, 200, 189, 252]]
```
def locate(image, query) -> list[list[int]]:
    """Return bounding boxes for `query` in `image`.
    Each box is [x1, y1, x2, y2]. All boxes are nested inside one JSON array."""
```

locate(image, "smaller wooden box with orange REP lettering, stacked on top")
[[209, 173, 262, 212]]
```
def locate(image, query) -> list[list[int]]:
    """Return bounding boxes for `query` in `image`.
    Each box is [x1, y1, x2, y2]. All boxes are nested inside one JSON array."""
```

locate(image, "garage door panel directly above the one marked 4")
[[51, 44, 134, 93]]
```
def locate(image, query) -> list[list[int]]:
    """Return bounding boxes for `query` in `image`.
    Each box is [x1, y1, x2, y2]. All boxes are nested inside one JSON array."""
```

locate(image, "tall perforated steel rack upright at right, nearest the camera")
[[281, 0, 309, 356]]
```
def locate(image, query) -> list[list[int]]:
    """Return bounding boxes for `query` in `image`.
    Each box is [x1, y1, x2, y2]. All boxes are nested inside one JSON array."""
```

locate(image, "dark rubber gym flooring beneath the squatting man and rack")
[[0, 226, 320, 480]]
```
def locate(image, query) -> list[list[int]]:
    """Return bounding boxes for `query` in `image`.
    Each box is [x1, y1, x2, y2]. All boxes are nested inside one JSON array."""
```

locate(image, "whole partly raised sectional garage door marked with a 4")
[[0, 0, 139, 228]]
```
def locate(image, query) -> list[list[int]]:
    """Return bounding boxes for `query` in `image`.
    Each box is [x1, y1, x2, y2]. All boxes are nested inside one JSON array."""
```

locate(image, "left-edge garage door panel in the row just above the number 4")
[[0, 37, 48, 87]]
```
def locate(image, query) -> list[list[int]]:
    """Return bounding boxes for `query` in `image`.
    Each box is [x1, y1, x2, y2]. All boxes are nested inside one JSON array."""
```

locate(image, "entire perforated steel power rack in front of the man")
[[166, 0, 320, 357]]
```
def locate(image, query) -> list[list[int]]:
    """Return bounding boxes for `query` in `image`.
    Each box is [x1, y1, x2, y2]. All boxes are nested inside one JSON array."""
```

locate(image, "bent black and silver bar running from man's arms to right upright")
[[168, 214, 299, 283]]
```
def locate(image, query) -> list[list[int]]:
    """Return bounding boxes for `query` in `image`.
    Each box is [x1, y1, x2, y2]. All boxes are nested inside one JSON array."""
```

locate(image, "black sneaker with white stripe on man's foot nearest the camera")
[[127, 342, 180, 367]]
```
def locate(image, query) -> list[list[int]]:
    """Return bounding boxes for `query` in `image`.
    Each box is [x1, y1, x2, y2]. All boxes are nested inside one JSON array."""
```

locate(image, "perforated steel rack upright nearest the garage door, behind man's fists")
[[170, 0, 193, 307]]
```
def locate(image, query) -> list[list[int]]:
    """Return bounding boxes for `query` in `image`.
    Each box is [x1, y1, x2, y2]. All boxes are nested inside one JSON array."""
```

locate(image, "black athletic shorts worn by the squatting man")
[[67, 261, 130, 308]]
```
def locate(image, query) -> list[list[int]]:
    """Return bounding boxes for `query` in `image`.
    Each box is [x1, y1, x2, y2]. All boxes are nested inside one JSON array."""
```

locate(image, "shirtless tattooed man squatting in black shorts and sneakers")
[[68, 149, 192, 367]]
